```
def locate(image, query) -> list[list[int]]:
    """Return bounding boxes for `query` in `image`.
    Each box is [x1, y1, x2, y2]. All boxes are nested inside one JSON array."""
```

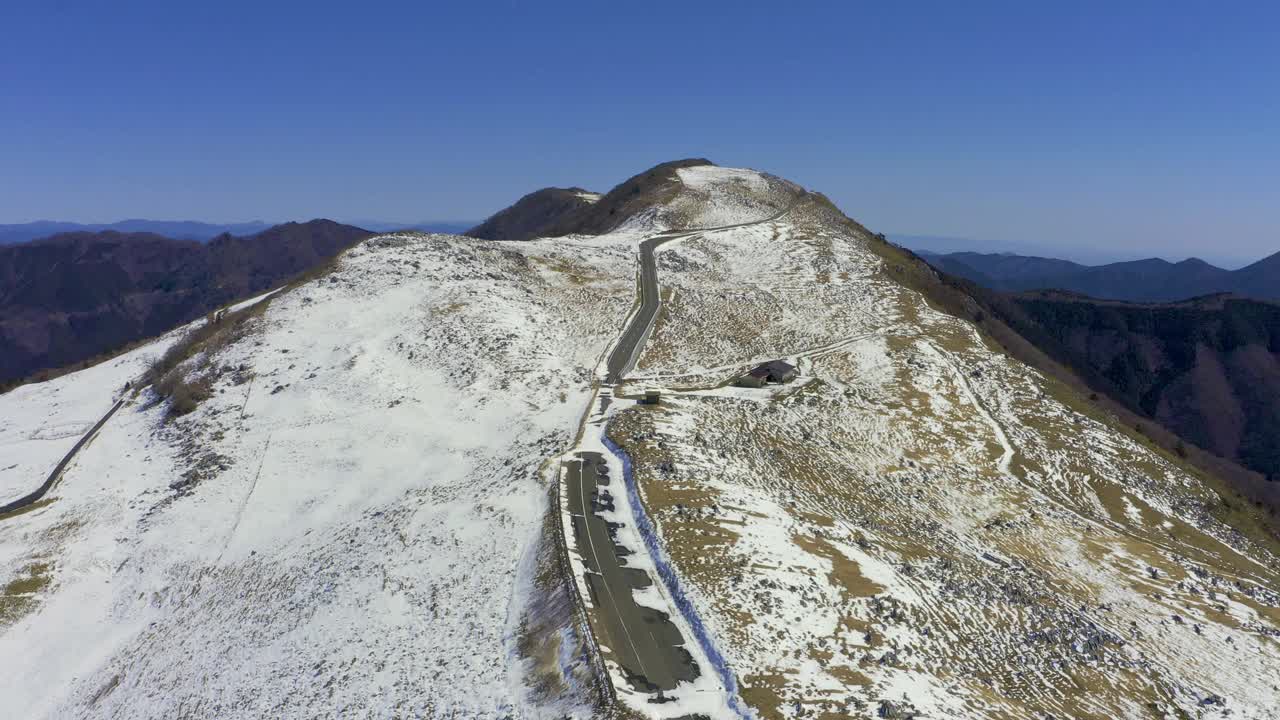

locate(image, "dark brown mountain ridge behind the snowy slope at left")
[[0, 220, 371, 383]]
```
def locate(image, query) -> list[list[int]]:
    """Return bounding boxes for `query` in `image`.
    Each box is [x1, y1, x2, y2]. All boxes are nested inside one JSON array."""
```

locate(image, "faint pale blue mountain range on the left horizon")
[[0, 219, 476, 245]]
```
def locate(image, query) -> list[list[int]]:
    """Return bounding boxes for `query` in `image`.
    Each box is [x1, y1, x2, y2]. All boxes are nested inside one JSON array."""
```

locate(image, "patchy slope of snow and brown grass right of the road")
[[611, 172, 1280, 719]]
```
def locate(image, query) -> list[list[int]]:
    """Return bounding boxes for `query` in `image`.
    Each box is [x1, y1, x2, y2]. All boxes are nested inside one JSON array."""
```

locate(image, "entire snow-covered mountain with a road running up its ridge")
[[0, 163, 1280, 719]]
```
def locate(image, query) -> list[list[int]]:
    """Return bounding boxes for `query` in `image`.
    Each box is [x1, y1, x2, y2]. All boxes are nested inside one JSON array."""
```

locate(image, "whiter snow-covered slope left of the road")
[[0, 228, 631, 717]]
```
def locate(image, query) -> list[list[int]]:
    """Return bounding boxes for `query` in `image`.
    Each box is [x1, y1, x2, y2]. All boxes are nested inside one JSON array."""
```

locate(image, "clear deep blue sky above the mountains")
[[0, 0, 1280, 264]]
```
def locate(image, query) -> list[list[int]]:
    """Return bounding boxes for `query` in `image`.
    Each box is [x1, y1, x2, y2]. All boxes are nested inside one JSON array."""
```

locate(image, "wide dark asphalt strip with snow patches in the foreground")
[[564, 452, 699, 693]]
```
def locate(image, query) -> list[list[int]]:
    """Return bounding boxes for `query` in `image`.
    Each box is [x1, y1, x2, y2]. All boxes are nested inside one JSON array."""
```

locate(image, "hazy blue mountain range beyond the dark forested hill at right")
[[923, 252, 1280, 302]]
